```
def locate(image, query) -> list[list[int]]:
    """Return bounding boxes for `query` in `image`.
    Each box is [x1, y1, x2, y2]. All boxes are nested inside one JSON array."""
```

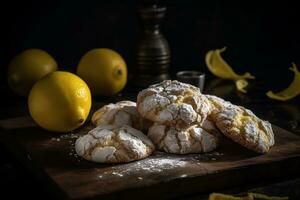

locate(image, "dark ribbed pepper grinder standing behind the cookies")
[[134, 4, 170, 87]]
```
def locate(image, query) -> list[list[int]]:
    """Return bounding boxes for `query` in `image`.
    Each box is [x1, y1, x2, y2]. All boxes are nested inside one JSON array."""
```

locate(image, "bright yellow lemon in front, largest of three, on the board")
[[28, 71, 92, 132]]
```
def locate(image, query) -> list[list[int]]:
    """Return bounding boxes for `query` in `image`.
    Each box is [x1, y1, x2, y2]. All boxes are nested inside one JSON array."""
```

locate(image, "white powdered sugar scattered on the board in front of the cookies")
[[98, 151, 224, 181]]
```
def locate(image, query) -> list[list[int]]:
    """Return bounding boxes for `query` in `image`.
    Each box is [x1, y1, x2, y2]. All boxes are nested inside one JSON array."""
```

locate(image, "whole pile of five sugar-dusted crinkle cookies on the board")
[[75, 80, 274, 163]]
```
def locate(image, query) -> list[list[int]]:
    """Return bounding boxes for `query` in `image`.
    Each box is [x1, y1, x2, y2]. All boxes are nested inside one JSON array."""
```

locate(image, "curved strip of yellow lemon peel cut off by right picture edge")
[[266, 63, 300, 101]]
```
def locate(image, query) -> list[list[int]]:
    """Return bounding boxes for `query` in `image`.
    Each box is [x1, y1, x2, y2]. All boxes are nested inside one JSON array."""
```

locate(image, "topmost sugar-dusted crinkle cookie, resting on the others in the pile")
[[137, 80, 210, 129]]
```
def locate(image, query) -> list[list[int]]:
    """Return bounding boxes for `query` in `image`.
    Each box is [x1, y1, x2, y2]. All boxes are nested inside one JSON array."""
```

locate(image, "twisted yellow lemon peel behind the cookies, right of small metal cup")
[[205, 47, 255, 93]]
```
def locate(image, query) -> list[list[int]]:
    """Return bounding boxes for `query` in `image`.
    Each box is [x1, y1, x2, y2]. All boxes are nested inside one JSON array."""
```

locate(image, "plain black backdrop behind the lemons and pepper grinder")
[[0, 0, 300, 90]]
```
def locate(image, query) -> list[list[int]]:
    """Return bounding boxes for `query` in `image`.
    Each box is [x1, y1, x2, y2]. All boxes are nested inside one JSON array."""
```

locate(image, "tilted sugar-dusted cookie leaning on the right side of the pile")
[[208, 97, 275, 153]]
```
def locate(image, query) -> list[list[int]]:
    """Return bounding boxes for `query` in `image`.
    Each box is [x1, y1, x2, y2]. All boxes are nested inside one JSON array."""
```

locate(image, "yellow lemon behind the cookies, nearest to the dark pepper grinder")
[[77, 48, 127, 96]]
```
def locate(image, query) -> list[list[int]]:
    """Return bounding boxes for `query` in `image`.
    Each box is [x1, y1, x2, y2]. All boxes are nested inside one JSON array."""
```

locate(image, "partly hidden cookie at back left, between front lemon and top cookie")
[[92, 101, 143, 130]]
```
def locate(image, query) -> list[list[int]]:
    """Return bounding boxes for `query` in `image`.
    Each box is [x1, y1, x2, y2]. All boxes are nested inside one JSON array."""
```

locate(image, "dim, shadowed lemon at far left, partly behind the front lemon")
[[7, 49, 57, 96]]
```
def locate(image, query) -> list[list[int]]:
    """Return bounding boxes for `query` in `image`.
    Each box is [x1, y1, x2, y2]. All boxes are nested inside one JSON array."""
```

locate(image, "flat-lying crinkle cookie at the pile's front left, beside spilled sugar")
[[75, 125, 154, 163]]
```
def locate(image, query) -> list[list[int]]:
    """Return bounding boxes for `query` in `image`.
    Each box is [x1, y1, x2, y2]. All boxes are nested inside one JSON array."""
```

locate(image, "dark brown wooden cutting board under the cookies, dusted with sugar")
[[1, 119, 300, 199]]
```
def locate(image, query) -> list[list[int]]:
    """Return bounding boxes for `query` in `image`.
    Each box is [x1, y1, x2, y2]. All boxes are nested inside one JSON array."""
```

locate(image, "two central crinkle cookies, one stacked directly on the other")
[[137, 80, 218, 154]]
